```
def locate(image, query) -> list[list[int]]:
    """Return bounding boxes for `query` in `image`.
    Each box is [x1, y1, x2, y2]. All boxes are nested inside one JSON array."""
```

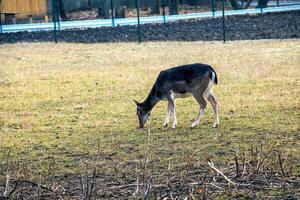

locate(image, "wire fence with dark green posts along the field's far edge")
[[0, 0, 300, 42]]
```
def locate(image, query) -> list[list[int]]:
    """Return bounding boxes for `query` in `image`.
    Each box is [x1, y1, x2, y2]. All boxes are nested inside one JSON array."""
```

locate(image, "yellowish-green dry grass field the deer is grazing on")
[[0, 40, 300, 198]]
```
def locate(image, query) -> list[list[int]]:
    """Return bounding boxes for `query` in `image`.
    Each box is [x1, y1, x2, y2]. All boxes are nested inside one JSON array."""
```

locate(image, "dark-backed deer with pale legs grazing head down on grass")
[[134, 63, 219, 128]]
